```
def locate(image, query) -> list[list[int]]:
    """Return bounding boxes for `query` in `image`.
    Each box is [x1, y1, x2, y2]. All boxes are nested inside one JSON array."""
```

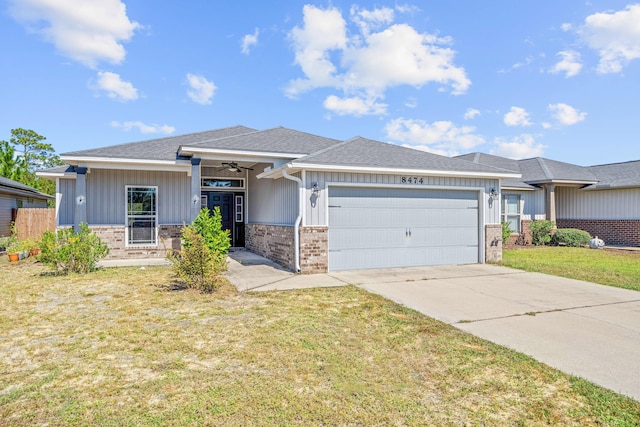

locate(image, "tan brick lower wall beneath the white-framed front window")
[[89, 225, 182, 259]]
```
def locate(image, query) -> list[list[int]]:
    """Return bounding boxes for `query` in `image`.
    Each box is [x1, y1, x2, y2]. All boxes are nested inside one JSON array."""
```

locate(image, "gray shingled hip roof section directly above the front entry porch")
[[182, 127, 339, 154]]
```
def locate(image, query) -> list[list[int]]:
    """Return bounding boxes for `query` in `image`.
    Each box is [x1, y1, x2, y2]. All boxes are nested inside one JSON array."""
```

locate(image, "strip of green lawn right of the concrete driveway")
[[502, 246, 640, 291]]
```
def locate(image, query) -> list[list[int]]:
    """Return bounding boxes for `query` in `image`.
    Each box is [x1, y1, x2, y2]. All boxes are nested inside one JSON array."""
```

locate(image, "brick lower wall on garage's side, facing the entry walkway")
[[245, 224, 295, 270]]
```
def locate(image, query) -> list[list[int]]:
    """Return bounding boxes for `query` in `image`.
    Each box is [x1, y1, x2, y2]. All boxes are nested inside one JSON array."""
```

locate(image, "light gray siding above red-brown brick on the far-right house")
[[556, 187, 640, 219]]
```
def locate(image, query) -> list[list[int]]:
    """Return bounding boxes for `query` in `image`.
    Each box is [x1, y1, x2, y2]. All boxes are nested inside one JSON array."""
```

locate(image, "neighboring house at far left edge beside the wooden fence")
[[0, 177, 54, 237]]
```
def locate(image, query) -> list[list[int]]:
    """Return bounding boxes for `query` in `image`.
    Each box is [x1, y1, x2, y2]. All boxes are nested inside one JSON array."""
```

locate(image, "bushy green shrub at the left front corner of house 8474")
[[38, 223, 109, 274]]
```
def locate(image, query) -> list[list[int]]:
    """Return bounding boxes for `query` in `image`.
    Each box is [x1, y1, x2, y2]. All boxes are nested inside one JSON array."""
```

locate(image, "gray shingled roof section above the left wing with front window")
[[62, 126, 256, 161]]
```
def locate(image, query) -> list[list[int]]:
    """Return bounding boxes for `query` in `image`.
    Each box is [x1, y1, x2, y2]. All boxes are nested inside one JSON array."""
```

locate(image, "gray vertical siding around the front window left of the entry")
[[85, 169, 191, 225]]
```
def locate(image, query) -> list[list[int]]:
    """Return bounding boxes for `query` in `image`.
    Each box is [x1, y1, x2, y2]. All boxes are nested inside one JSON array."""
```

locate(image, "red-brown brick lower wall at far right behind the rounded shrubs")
[[557, 219, 640, 247]]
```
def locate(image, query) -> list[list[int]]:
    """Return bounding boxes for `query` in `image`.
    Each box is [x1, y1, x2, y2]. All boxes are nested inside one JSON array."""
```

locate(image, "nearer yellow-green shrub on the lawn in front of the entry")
[[167, 225, 227, 292]]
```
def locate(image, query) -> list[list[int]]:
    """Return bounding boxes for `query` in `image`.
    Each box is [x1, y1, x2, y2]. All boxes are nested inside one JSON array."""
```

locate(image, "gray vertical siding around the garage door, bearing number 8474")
[[305, 172, 500, 225]]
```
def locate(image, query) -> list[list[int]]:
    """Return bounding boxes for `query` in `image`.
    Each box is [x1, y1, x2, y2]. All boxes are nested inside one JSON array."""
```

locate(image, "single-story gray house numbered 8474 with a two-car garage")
[[39, 126, 519, 273]]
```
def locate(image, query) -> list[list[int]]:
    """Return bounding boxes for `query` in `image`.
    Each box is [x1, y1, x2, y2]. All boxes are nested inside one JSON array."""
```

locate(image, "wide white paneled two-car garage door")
[[329, 187, 479, 271]]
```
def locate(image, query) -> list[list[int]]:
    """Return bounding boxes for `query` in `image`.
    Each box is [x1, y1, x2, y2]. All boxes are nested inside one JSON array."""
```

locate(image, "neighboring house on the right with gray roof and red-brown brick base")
[[457, 153, 640, 246]]
